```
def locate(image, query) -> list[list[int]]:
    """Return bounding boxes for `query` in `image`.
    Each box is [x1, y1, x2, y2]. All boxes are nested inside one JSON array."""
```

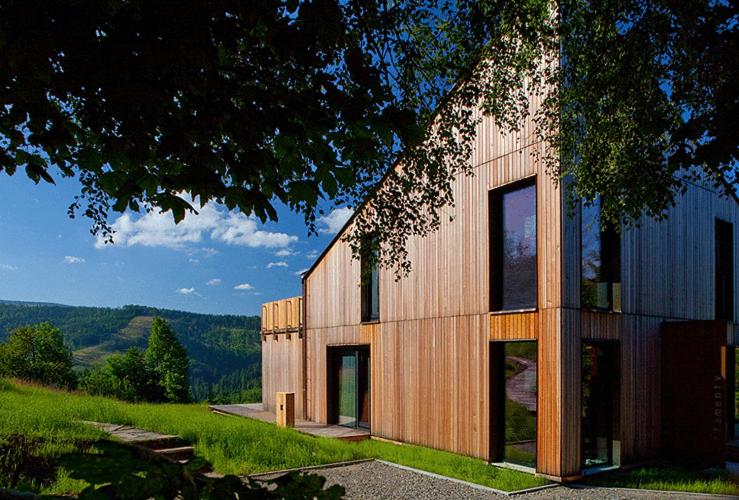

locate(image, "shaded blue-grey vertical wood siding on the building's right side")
[[562, 178, 739, 464]]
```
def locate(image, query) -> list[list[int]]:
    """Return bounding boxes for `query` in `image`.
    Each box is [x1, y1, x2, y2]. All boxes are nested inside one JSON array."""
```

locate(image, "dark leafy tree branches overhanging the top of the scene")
[[0, 0, 739, 273]]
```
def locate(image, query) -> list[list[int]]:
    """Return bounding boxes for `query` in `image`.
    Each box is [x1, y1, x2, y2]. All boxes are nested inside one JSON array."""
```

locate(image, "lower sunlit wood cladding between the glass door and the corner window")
[[371, 315, 489, 458]]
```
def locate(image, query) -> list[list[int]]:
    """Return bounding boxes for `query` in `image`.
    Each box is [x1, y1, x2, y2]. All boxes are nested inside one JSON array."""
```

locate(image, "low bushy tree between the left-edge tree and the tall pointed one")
[[80, 347, 165, 403]]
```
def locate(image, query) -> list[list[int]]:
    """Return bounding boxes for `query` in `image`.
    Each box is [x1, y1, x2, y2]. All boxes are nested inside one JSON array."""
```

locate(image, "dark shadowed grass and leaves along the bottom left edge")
[[0, 435, 344, 500]]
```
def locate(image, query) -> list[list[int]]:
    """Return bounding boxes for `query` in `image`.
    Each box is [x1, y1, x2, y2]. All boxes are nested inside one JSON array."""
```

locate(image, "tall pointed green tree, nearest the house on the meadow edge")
[[145, 317, 190, 402]]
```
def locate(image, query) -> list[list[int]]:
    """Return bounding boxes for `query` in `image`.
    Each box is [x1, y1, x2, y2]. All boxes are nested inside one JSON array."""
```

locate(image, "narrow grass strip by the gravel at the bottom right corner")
[[587, 465, 739, 495]]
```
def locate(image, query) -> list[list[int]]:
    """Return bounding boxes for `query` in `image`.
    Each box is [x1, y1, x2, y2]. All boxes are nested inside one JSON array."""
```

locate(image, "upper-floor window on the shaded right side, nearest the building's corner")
[[580, 200, 621, 311]]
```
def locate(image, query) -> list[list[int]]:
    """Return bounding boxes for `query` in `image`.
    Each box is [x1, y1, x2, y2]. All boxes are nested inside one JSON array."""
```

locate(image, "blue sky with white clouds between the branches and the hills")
[[0, 171, 351, 314]]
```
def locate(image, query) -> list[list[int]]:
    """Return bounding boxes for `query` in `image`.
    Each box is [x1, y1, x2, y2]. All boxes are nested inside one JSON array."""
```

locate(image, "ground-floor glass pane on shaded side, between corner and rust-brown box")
[[582, 341, 621, 467]]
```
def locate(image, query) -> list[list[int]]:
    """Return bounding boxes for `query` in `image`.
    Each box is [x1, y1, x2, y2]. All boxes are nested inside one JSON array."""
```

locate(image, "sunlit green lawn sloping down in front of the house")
[[0, 379, 547, 493]]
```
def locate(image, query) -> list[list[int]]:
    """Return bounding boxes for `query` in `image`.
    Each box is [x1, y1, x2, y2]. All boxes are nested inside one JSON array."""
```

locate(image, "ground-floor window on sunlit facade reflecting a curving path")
[[490, 341, 538, 468]]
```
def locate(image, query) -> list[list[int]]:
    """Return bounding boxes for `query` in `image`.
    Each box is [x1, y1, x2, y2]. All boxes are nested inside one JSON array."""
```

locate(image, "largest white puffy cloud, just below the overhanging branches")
[[95, 196, 298, 249]]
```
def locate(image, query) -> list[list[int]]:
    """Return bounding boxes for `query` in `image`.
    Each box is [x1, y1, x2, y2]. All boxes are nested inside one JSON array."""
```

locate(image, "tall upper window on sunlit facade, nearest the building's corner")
[[489, 181, 537, 311]]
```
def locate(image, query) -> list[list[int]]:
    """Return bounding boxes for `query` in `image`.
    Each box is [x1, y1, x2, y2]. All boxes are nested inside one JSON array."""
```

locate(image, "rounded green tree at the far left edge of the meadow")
[[0, 323, 76, 388]]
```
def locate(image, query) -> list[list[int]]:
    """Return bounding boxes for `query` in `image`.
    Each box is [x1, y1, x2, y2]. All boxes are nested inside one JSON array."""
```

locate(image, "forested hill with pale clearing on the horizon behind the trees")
[[0, 300, 261, 399]]
